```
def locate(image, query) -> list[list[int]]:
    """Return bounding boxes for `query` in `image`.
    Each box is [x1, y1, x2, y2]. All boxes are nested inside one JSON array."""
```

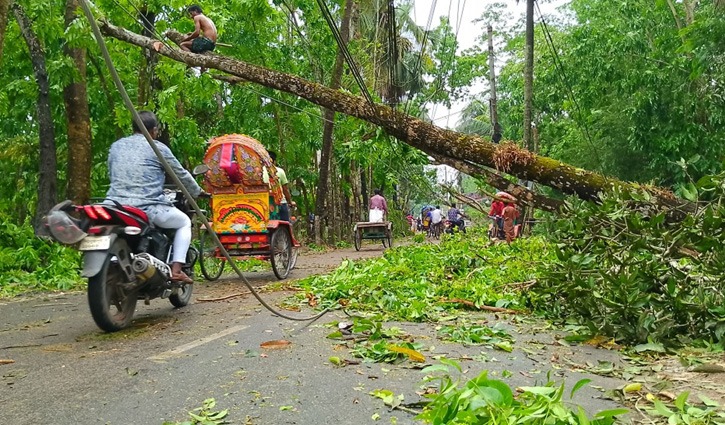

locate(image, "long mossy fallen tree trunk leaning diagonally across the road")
[[100, 22, 689, 209]]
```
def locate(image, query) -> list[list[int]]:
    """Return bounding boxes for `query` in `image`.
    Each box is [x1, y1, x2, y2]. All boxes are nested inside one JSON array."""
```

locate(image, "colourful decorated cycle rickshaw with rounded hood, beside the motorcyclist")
[[200, 134, 300, 280]]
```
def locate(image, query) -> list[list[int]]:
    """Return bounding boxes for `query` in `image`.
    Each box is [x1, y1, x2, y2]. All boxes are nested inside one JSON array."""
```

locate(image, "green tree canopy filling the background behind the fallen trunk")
[[0, 0, 725, 235]]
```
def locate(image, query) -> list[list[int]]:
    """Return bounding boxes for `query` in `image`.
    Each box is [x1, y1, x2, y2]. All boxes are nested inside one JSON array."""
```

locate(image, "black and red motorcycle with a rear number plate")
[[46, 165, 208, 332]]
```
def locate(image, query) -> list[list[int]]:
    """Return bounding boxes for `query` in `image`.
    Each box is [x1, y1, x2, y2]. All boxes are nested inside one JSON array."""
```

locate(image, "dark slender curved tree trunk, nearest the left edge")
[[12, 3, 58, 235]]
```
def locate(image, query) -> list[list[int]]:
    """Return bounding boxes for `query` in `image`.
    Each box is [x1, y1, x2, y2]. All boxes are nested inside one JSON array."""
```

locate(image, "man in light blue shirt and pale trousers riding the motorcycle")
[[106, 111, 202, 283]]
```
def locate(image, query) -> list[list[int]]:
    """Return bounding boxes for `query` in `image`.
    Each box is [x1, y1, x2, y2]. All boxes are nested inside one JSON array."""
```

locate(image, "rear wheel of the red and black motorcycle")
[[88, 239, 138, 332]]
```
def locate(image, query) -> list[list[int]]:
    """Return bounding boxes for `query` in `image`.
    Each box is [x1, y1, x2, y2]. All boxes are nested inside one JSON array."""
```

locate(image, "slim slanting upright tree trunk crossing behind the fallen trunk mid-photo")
[[315, 0, 355, 245]]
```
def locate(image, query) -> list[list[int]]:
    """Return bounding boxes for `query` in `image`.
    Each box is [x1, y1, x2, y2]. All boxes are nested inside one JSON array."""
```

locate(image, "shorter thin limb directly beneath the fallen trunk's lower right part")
[[431, 155, 564, 212]]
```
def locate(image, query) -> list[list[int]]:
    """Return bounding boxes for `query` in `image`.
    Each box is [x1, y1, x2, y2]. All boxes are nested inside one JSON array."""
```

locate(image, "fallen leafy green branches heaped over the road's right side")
[[284, 175, 725, 424]]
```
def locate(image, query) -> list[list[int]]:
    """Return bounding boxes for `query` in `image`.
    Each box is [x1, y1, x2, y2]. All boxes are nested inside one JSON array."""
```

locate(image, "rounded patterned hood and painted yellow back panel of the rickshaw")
[[204, 134, 283, 234]]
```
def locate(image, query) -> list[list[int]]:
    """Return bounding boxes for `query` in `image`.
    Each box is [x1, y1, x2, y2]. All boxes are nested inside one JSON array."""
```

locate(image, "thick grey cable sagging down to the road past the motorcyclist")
[[79, 0, 330, 322]]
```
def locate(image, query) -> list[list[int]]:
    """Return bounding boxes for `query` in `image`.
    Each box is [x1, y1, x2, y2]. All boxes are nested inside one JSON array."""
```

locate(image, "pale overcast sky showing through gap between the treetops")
[[412, 0, 570, 127]]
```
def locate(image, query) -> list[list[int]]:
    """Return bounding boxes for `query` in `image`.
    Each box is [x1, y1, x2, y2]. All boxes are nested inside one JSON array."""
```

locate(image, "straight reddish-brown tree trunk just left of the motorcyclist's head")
[[63, 0, 93, 204]]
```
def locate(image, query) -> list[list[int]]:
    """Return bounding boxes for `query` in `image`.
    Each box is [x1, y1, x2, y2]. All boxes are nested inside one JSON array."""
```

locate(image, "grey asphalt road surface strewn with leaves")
[[0, 246, 623, 425]]
